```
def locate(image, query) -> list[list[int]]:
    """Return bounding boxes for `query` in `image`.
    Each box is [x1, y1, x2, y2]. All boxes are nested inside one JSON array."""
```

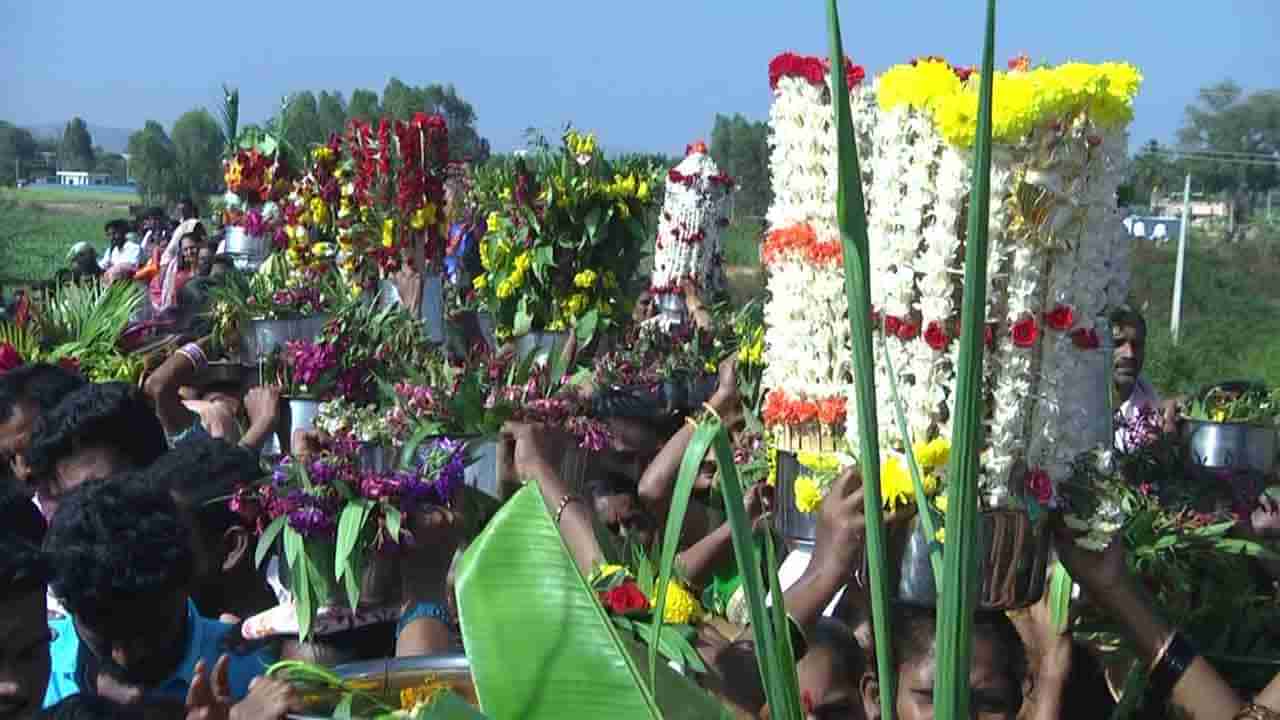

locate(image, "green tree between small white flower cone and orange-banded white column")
[[710, 114, 773, 220]]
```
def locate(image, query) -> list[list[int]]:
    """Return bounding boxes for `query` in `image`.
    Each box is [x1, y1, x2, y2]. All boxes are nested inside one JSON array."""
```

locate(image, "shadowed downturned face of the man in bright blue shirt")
[[72, 592, 187, 691]]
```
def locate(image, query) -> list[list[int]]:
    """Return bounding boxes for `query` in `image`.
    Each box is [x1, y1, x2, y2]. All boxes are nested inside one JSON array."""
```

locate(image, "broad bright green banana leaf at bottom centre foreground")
[[456, 487, 731, 720]]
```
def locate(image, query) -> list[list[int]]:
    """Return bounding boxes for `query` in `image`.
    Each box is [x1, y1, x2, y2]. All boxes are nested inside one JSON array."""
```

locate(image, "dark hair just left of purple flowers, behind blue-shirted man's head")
[[146, 437, 266, 537]]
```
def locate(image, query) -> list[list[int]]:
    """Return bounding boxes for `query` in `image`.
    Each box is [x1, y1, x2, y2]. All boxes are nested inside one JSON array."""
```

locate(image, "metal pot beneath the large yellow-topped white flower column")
[[860, 507, 1051, 610]]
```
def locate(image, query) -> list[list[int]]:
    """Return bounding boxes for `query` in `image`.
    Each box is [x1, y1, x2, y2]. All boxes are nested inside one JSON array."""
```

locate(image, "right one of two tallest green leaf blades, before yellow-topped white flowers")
[[933, 0, 996, 717]]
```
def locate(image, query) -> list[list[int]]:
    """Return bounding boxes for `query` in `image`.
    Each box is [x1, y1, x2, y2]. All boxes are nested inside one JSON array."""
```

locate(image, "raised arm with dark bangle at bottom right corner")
[[1055, 529, 1244, 720]]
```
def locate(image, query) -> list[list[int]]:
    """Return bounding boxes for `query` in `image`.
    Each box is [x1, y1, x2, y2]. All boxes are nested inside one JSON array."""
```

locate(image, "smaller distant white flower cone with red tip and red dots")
[[649, 142, 733, 312]]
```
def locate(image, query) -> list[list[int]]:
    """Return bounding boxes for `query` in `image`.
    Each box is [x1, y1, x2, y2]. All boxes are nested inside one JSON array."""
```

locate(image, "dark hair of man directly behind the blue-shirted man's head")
[[28, 383, 169, 483]]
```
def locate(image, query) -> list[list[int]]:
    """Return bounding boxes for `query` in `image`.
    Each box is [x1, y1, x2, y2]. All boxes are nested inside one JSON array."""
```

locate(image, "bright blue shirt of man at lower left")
[[45, 601, 270, 708]]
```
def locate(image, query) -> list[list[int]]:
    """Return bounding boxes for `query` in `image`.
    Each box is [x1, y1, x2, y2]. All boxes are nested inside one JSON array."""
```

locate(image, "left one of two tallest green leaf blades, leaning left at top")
[[827, 0, 897, 720]]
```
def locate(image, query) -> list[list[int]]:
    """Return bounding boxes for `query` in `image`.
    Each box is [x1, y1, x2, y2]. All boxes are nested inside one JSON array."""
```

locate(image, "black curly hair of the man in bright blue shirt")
[[45, 473, 193, 624]]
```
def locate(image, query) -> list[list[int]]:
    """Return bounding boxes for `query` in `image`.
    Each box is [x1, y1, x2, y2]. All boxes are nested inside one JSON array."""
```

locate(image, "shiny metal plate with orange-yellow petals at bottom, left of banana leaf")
[[289, 655, 480, 720]]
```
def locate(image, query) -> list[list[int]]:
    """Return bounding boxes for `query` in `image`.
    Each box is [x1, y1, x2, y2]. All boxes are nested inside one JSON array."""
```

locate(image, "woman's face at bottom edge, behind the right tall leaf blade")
[[863, 635, 1021, 720]]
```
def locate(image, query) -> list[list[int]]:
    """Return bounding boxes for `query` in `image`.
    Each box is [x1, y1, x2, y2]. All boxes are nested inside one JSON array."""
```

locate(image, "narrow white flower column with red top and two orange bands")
[[762, 53, 870, 451]]
